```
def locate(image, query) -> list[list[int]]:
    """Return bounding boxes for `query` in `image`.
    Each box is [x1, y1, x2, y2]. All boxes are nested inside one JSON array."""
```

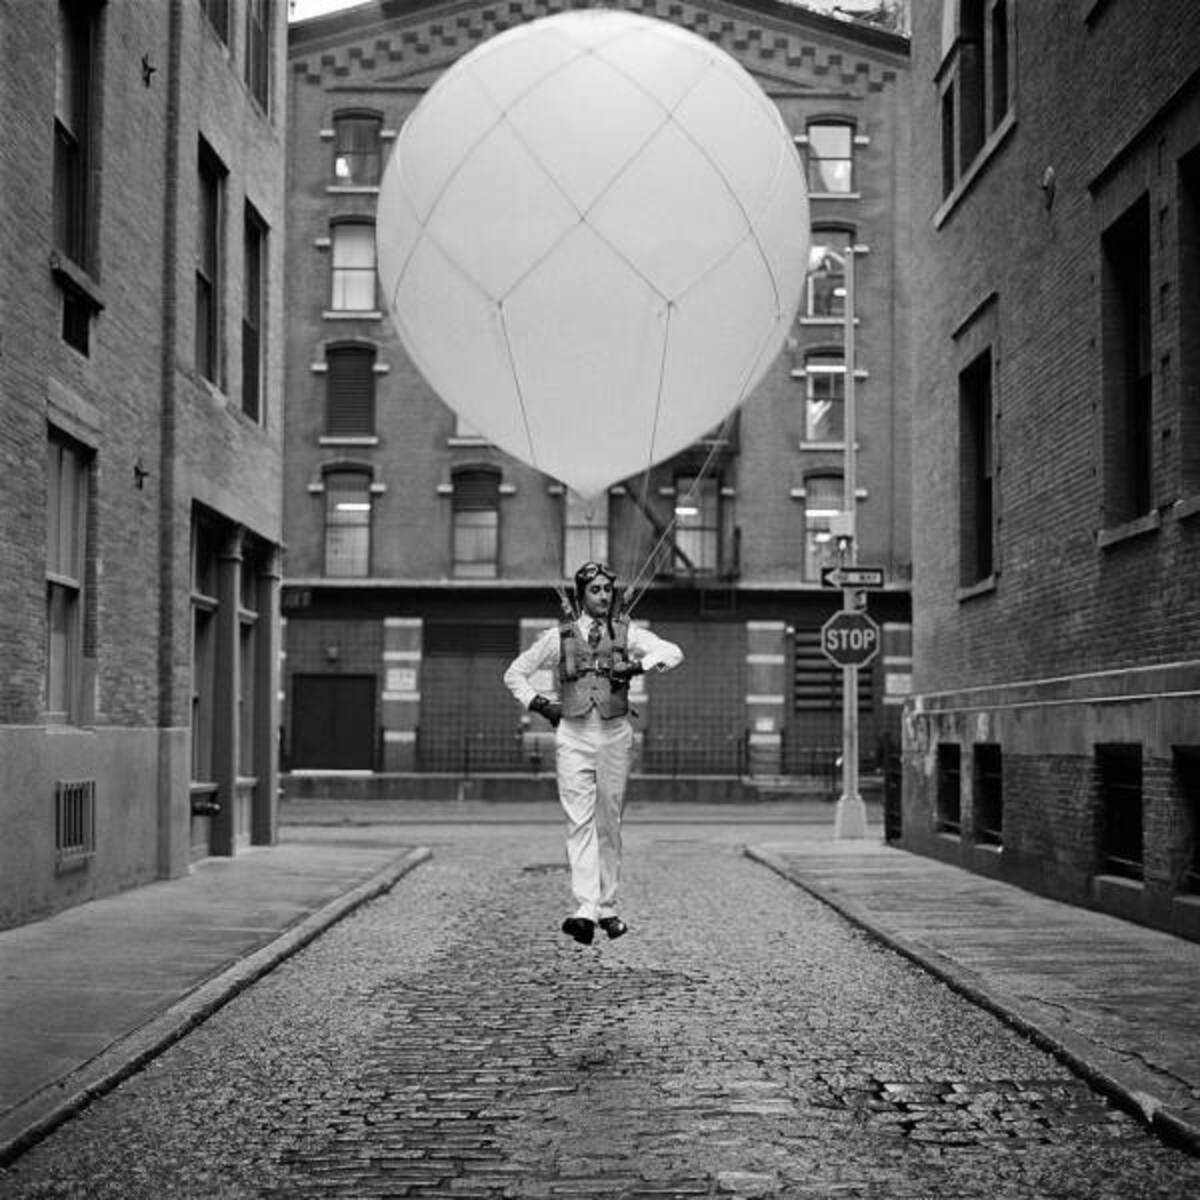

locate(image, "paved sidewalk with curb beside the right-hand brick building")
[[746, 832, 1200, 1154]]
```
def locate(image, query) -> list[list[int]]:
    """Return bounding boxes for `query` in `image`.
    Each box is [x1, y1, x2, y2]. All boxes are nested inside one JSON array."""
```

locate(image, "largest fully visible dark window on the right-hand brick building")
[[1100, 196, 1153, 526]]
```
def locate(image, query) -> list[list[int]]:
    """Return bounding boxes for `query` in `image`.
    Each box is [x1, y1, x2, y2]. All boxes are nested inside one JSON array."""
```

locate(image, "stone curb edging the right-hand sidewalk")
[[744, 846, 1200, 1157]]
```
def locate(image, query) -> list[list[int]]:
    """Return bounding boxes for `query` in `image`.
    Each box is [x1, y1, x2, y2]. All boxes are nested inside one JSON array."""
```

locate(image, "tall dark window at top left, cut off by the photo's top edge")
[[54, 0, 95, 269]]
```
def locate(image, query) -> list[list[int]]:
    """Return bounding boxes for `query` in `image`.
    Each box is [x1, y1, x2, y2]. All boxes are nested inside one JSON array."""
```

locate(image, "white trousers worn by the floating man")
[[554, 708, 634, 920]]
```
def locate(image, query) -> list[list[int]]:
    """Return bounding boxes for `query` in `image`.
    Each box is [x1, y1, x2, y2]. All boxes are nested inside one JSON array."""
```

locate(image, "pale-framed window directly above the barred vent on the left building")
[[46, 433, 91, 721]]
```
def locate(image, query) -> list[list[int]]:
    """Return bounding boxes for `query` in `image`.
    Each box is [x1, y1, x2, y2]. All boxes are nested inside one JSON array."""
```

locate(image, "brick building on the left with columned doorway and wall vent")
[[0, 0, 287, 926]]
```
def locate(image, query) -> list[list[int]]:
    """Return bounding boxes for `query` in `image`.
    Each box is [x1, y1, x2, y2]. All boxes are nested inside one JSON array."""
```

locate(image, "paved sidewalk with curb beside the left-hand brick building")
[[0, 828, 430, 1164]]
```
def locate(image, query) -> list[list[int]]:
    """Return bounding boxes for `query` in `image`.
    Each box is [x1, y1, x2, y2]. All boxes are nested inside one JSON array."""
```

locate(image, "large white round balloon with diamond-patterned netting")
[[376, 10, 809, 497]]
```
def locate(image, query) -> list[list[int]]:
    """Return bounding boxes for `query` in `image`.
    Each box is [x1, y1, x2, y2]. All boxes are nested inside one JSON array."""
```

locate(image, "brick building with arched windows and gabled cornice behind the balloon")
[[283, 0, 911, 796]]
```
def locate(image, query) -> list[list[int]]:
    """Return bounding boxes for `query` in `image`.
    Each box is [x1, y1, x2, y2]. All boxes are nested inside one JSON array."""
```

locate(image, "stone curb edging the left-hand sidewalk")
[[0, 846, 432, 1168]]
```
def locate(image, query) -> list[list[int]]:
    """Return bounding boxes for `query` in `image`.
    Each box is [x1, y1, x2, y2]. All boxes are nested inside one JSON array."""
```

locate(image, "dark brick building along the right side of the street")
[[902, 0, 1200, 937]]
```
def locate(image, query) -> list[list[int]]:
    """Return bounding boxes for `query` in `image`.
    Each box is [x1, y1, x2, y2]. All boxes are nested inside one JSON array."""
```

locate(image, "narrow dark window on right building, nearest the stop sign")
[[959, 350, 995, 587]]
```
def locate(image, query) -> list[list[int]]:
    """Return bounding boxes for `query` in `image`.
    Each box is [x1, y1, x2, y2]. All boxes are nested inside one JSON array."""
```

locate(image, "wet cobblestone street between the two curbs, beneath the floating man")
[[0, 824, 1200, 1200]]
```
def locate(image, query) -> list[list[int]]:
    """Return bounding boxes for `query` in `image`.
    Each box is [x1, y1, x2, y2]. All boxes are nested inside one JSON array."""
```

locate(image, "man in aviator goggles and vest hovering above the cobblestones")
[[504, 563, 683, 946]]
